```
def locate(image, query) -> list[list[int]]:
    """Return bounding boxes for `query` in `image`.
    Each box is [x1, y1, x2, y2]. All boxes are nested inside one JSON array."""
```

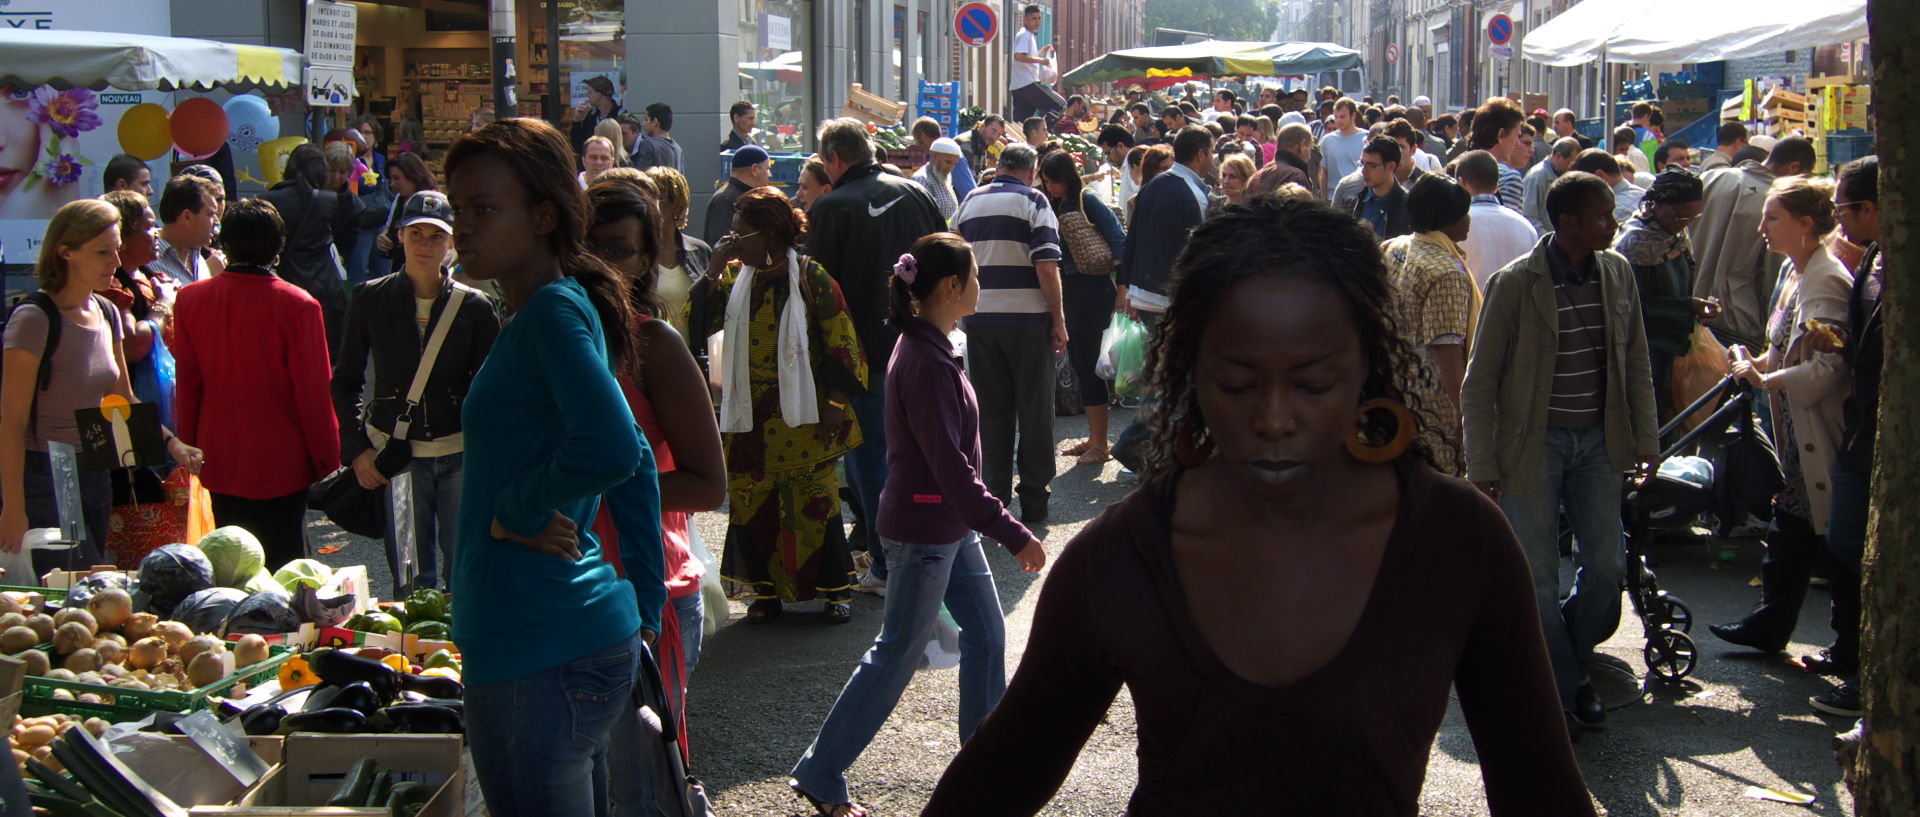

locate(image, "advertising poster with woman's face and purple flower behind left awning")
[[0, 0, 173, 265]]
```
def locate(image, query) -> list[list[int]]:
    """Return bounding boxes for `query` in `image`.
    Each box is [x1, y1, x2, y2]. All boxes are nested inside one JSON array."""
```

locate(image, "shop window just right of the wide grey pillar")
[[739, 0, 818, 153]]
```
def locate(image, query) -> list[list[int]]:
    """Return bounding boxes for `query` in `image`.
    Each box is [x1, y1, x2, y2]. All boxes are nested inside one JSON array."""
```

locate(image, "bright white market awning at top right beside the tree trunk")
[[1521, 0, 1866, 67]]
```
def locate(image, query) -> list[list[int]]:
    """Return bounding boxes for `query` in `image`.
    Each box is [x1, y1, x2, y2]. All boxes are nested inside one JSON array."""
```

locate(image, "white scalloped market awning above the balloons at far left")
[[0, 29, 305, 90]]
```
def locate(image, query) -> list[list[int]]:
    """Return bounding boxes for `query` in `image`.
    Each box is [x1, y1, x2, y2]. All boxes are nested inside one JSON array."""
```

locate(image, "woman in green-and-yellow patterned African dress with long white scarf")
[[697, 188, 866, 623]]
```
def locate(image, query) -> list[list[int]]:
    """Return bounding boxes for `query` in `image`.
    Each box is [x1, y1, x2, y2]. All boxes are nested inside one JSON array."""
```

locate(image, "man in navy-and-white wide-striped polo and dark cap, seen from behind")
[[954, 144, 1068, 525]]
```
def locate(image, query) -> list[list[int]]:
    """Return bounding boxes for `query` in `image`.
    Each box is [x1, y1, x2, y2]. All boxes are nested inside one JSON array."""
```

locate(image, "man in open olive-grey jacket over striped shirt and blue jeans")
[[1461, 171, 1659, 727]]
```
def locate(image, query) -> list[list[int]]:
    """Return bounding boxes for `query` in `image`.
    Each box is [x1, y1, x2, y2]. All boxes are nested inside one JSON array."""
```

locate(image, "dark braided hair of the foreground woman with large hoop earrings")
[[1146, 194, 1461, 474]]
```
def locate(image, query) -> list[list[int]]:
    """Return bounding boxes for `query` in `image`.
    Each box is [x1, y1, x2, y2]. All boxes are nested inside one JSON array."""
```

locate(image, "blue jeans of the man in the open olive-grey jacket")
[[1500, 428, 1624, 708]]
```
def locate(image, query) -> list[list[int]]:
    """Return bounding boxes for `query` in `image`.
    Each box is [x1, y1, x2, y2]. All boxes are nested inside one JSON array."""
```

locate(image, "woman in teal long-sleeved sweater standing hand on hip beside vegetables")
[[447, 119, 666, 817]]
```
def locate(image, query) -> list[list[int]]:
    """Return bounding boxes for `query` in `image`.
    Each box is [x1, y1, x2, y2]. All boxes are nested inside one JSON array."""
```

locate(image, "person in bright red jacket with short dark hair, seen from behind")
[[173, 199, 340, 566]]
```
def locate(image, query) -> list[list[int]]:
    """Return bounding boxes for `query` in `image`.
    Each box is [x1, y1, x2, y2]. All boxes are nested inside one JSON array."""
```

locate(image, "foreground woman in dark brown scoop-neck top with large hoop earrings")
[[924, 196, 1594, 817]]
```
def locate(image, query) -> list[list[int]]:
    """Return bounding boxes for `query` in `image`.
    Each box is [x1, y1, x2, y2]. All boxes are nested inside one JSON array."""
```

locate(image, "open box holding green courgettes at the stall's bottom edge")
[[188, 733, 467, 817]]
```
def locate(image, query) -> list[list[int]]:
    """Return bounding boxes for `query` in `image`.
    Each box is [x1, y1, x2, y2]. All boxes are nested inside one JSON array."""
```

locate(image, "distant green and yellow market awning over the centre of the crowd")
[[1062, 40, 1359, 86]]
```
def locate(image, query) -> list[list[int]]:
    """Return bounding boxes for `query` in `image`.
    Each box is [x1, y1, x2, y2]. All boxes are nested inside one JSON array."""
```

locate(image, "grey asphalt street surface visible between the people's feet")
[[313, 410, 1853, 817]]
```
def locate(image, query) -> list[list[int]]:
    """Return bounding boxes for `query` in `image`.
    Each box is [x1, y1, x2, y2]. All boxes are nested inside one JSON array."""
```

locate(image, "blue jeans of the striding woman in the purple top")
[[793, 533, 1006, 804]]
